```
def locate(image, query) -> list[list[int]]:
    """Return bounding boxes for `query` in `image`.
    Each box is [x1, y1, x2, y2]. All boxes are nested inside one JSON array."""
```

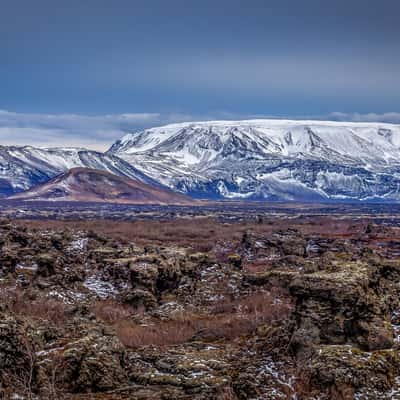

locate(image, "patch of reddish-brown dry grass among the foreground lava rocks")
[[108, 292, 292, 348]]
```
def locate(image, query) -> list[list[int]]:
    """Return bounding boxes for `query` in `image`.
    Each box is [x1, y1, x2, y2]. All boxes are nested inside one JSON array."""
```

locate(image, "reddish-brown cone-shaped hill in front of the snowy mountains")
[[10, 168, 195, 205]]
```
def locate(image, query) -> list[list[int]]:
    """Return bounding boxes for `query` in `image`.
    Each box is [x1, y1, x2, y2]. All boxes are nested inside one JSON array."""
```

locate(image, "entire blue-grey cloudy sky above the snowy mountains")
[[0, 0, 400, 150]]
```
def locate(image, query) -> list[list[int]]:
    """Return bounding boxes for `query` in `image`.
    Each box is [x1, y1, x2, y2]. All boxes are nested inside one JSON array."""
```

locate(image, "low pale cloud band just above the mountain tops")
[[0, 110, 400, 151]]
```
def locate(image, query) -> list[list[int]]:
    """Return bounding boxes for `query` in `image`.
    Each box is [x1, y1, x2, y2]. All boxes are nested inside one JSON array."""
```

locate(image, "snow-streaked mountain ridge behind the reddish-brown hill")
[[0, 146, 154, 196]]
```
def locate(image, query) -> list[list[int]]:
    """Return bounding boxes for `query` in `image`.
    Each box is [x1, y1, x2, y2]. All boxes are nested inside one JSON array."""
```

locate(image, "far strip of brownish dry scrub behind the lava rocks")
[[18, 217, 367, 250]]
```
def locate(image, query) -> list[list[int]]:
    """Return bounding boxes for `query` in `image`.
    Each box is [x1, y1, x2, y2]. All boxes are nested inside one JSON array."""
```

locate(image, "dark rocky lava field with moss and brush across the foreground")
[[0, 215, 400, 400]]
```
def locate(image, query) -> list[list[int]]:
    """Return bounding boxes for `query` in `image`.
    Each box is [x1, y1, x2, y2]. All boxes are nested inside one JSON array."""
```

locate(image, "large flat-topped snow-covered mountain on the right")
[[107, 120, 400, 201]]
